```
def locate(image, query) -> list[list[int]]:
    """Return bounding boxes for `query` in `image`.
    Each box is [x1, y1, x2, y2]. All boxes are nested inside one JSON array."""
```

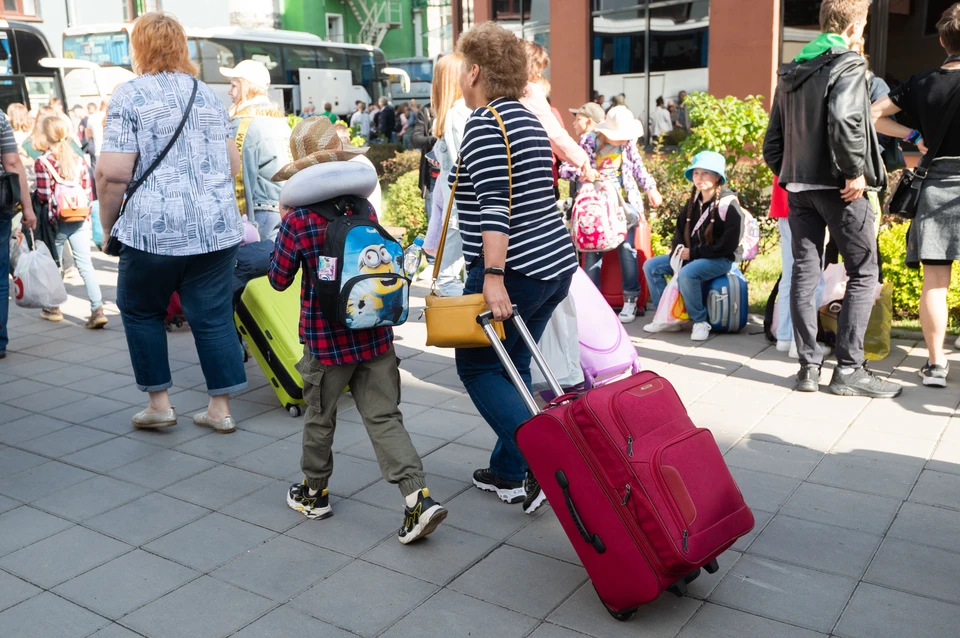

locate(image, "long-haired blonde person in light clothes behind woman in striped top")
[[424, 53, 470, 297]]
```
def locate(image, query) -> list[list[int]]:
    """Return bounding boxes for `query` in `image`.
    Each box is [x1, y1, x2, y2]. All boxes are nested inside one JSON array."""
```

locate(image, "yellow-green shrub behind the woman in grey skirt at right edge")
[[879, 222, 960, 325]]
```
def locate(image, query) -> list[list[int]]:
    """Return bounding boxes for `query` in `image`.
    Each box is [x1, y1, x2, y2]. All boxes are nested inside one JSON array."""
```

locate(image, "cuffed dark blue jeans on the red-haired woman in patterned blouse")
[[117, 246, 247, 396]]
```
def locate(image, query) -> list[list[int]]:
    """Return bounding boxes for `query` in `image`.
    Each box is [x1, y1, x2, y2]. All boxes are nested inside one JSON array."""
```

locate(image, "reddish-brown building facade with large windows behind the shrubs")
[[453, 0, 955, 140]]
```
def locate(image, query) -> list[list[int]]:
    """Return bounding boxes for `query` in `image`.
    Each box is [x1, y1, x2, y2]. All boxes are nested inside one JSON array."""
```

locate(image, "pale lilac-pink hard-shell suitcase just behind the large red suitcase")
[[569, 268, 640, 388]]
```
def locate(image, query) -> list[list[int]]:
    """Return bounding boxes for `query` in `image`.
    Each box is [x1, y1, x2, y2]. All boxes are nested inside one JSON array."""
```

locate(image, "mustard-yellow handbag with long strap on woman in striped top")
[[423, 106, 513, 348]]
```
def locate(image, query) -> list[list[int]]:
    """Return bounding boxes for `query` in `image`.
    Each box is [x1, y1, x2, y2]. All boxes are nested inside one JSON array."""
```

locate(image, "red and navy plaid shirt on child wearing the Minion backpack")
[[268, 207, 393, 365]]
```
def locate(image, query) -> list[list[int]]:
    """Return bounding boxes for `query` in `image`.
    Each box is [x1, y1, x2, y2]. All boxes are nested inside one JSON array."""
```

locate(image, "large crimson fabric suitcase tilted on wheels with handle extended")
[[478, 311, 753, 620]]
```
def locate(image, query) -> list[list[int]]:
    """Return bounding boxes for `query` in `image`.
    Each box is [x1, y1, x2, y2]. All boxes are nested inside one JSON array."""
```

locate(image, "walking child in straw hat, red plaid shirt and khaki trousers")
[[269, 117, 447, 544]]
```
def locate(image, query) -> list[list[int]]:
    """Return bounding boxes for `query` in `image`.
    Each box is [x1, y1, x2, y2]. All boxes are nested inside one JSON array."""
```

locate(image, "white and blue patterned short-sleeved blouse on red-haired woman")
[[102, 73, 243, 256]]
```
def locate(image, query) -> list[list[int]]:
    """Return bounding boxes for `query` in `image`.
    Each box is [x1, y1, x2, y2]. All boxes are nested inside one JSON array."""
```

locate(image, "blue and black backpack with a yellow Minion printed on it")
[[308, 196, 410, 330]]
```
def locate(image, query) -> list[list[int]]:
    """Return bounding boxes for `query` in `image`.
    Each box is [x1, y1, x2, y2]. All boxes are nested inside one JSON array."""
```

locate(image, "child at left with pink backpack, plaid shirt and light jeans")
[[34, 117, 107, 329]]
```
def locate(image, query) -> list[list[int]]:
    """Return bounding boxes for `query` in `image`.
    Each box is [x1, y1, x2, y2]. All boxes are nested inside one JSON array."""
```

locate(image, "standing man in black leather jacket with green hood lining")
[[763, 0, 902, 398]]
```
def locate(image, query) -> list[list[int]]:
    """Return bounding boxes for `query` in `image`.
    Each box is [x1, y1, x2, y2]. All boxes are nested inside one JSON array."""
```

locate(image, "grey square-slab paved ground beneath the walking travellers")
[[0, 254, 960, 638]]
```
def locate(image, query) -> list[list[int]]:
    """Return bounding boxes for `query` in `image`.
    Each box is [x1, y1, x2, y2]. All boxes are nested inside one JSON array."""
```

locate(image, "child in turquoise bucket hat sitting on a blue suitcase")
[[643, 151, 743, 341]]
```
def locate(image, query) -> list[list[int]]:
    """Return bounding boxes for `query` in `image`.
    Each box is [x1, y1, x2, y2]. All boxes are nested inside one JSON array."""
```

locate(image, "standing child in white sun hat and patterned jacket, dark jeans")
[[560, 106, 663, 323]]
